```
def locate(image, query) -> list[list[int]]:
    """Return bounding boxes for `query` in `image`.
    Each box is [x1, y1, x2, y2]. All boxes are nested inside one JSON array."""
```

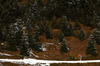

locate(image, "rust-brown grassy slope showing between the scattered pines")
[[0, 24, 100, 60]]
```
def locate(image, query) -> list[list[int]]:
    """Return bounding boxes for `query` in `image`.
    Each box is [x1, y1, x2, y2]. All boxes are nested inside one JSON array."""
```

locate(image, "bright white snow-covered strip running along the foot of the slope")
[[0, 59, 100, 66]]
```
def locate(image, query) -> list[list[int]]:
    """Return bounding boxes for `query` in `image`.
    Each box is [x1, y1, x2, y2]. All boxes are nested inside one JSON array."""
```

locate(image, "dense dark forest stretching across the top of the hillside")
[[0, 0, 100, 26]]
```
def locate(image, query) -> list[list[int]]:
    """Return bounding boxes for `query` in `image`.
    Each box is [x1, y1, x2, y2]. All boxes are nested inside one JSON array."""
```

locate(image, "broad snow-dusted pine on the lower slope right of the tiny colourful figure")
[[86, 40, 98, 56]]
